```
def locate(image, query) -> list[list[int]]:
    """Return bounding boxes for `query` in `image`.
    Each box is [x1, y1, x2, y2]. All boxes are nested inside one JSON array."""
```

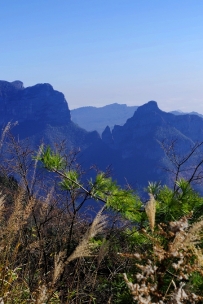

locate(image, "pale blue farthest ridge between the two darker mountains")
[[71, 103, 138, 134]]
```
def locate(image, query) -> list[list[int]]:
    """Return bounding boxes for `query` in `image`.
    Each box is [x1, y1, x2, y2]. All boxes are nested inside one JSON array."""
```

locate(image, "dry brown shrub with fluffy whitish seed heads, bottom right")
[[124, 211, 203, 304]]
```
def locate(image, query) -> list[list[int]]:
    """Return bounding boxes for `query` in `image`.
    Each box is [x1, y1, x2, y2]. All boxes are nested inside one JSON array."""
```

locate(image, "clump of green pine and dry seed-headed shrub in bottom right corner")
[[120, 179, 203, 304]]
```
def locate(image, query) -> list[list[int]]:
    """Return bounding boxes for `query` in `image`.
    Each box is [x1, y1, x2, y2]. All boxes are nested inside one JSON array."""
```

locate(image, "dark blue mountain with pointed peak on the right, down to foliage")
[[79, 101, 203, 194]]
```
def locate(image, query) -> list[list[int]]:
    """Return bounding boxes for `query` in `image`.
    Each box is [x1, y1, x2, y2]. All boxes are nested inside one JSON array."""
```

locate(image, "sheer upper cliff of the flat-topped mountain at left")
[[0, 81, 70, 125]]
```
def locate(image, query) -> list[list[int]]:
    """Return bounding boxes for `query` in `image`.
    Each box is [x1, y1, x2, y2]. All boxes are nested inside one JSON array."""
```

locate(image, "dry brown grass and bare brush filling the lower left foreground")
[[0, 179, 129, 303]]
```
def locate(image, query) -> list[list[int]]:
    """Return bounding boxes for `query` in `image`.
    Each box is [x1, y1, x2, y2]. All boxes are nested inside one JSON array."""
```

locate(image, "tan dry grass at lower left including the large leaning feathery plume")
[[0, 190, 107, 304]]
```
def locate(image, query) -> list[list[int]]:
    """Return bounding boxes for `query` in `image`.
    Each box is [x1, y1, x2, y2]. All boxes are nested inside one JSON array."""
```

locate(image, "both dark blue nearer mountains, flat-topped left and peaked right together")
[[0, 81, 203, 195]]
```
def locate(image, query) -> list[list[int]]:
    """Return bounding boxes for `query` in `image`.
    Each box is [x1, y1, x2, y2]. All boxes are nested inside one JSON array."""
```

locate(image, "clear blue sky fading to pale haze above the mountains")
[[0, 0, 203, 113]]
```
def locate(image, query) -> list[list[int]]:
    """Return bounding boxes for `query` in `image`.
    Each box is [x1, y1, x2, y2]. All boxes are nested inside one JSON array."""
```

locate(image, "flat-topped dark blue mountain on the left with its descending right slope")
[[0, 81, 99, 149]]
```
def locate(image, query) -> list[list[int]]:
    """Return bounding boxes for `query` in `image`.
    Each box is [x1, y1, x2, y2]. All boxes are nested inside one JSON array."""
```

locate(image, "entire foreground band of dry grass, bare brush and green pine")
[[0, 134, 203, 304]]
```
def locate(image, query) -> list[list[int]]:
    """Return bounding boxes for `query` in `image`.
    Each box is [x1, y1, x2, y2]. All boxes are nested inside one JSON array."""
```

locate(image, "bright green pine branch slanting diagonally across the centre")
[[38, 147, 142, 222]]
